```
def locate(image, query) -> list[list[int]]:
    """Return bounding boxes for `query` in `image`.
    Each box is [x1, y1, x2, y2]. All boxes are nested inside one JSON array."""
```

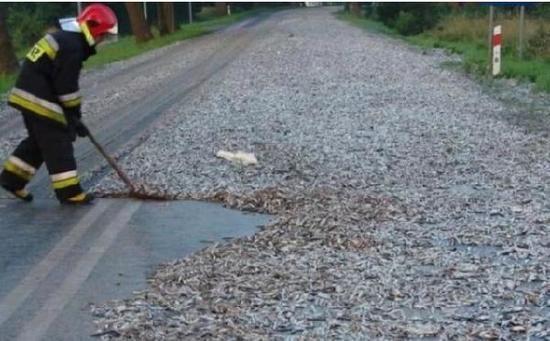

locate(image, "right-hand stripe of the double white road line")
[[17, 202, 141, 341]]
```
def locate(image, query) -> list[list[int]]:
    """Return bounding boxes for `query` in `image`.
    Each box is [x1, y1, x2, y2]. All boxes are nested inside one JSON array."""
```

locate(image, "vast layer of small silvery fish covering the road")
[[2, 8, 550, 340]]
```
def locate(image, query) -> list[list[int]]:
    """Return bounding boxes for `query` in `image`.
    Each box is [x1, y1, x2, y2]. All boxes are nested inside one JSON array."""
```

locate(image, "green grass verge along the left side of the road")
[[0, 8, 266, 95]]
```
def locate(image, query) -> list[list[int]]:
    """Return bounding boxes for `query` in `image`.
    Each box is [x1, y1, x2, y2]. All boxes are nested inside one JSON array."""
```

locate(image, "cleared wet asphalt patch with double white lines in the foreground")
[[0, 199, 269, 340]]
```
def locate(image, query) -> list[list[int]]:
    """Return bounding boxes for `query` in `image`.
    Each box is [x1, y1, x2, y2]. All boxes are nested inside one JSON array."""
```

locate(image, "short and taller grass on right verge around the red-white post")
[[337, 13, 550, 92]]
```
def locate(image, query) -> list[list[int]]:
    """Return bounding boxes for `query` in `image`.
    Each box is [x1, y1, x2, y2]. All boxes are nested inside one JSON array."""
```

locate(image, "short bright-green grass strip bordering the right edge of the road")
[[337, 13, 550, 92]]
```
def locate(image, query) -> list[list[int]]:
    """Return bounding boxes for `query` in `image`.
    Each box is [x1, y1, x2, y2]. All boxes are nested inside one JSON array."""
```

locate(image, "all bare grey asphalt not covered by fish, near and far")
[[0, 17, 268, 340]]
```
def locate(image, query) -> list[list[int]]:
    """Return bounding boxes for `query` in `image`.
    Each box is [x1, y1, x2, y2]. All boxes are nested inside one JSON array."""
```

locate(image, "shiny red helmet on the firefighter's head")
[[76, 4, 118, 39]]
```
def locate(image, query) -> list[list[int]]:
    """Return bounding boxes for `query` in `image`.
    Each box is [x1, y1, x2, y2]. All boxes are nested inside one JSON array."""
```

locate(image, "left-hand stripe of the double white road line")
[[0, 201, 109, 325]]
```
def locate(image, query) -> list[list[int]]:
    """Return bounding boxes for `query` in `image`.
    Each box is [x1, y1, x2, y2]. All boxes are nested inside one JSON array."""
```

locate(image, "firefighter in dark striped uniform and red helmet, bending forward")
[[0, 4, 118, 204]]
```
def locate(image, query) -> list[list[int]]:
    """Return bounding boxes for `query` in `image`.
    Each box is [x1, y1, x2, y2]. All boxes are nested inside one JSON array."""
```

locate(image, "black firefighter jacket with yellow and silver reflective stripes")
[[8, 31, 95, 126]]
